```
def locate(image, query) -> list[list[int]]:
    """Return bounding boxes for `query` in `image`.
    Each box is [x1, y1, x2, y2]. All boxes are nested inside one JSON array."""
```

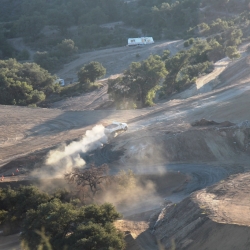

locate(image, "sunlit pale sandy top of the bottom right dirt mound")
[[193, 173, 250, 226]]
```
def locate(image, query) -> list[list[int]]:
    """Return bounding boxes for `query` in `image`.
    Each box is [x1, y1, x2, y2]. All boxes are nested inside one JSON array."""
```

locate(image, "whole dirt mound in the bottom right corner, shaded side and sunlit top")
[[151, 173, 250, 250]]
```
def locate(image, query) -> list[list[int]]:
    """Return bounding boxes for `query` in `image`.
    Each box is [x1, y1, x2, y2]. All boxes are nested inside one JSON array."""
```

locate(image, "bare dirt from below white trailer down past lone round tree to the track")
[[50, 40, 183, 111]]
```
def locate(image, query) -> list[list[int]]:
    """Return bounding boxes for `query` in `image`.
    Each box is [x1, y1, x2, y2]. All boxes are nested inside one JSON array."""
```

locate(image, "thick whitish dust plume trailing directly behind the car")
[[32, 125, 107, 179]]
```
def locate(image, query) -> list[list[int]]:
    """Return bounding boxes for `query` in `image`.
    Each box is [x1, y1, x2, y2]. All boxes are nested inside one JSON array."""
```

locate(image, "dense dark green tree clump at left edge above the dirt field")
[[0, 59, 58, 105]]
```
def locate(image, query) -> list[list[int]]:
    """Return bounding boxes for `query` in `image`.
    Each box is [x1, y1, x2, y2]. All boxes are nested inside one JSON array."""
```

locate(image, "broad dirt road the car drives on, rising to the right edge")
[[0, 60, 250, 164]]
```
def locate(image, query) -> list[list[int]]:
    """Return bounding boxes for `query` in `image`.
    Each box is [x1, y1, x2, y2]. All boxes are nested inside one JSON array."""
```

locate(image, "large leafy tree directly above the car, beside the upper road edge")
[[108, 55, 167, 108]]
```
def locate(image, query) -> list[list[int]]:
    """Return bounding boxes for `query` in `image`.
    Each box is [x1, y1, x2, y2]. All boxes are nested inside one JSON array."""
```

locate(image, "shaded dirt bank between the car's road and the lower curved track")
[[94, 122, 250, 166]]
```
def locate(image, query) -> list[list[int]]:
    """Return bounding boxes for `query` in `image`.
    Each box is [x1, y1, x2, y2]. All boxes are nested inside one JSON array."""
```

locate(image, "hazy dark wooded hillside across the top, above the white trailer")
[[0, 0, 249, 54]]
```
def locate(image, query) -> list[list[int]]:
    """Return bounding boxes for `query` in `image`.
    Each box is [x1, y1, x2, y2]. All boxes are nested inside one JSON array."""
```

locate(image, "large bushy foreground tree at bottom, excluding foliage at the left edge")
[[21, 199, 125, 250]]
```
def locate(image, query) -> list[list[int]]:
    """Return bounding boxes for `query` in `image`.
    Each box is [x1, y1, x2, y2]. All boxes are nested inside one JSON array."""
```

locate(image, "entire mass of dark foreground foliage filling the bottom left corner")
[[0, 186, 125, 250]]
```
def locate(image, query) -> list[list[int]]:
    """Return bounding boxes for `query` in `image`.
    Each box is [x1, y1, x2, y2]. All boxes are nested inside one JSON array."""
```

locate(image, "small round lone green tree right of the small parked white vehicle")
[[77, 61, 106, 85]]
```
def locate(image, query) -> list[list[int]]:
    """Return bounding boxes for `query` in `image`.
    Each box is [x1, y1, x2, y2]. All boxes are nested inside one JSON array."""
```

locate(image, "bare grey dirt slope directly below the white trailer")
[[56, 40, 183, 83]]
